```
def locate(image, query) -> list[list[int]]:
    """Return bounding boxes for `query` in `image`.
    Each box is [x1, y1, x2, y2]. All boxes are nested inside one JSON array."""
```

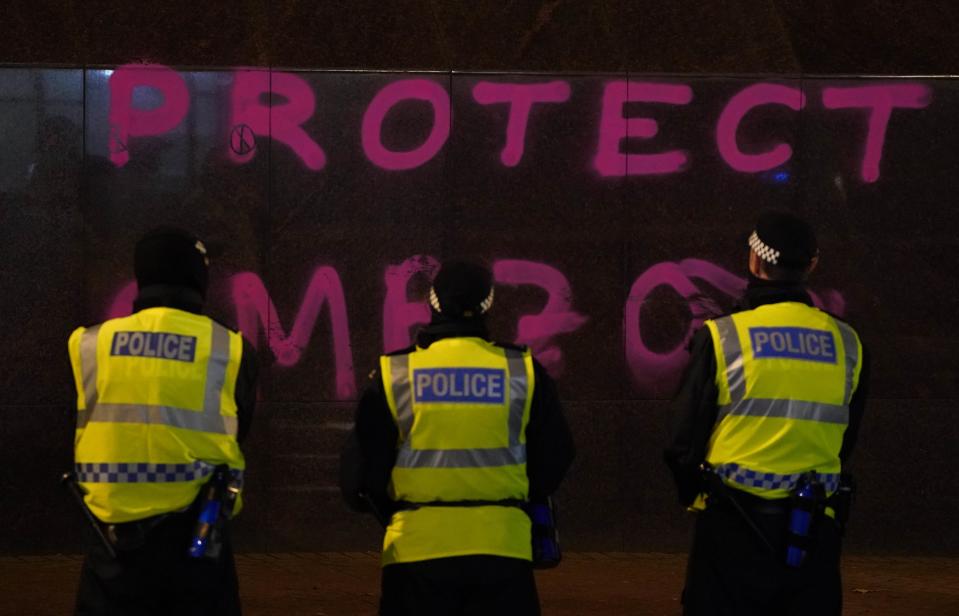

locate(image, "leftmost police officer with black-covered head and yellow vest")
[[69, 228, 256, 615]]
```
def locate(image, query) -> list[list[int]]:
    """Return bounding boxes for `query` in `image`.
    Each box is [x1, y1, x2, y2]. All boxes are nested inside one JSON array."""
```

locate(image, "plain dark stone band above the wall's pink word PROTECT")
[[0, 0, 959, 74]]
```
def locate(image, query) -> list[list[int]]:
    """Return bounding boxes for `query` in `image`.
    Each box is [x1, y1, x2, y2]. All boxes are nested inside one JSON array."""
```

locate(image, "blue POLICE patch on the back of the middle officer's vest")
[[413, 368, 506, 404]]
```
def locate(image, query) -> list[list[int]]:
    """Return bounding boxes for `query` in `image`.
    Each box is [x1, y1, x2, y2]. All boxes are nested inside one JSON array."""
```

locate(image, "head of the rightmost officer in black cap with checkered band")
[[749, 209, 819, 282]]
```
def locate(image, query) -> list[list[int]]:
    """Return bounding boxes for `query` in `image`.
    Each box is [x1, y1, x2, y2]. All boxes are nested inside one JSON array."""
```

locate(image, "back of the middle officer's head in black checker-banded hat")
[[430, 259, 493, 319]]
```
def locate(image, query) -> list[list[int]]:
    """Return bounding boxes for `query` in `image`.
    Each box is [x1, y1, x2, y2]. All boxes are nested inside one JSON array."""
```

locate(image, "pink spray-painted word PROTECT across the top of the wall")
[[107, 65, 932, 183]]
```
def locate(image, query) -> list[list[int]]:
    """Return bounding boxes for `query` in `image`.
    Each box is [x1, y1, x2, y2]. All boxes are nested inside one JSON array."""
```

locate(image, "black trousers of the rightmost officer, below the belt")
[[683, 496, 842, 616]]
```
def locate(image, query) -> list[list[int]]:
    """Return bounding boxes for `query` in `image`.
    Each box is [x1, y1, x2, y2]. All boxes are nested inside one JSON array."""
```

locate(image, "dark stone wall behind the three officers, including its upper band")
[[0, 0, 959, 554]]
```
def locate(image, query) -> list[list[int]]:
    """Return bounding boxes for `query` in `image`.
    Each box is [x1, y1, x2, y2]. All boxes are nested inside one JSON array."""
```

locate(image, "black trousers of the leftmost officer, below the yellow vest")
[[76, 508, 240, 616]]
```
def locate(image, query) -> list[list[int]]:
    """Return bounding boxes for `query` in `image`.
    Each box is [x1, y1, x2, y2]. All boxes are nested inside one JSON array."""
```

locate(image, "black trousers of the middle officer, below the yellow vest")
[[380, 556, 540, 616]]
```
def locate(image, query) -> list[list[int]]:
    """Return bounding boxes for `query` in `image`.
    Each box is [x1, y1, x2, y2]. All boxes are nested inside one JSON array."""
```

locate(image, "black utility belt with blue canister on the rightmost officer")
[[703, 465, 855, 567]]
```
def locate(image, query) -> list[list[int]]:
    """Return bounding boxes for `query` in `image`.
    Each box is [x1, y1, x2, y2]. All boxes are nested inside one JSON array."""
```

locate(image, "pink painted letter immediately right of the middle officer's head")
[[493, 259, 588, 377]]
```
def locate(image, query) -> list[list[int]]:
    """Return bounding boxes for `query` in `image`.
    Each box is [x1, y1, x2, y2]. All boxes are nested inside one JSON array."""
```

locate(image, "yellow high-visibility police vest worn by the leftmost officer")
[[68, 308, 245, 523]]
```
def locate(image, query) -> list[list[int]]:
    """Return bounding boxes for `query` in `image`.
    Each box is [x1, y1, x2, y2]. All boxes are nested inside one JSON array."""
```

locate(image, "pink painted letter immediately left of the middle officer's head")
[[383, 255, 440, 353]]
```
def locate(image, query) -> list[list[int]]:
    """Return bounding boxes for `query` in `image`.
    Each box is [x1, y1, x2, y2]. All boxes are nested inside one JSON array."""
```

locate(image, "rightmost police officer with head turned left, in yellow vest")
[[665, 211, 868, 616]]
